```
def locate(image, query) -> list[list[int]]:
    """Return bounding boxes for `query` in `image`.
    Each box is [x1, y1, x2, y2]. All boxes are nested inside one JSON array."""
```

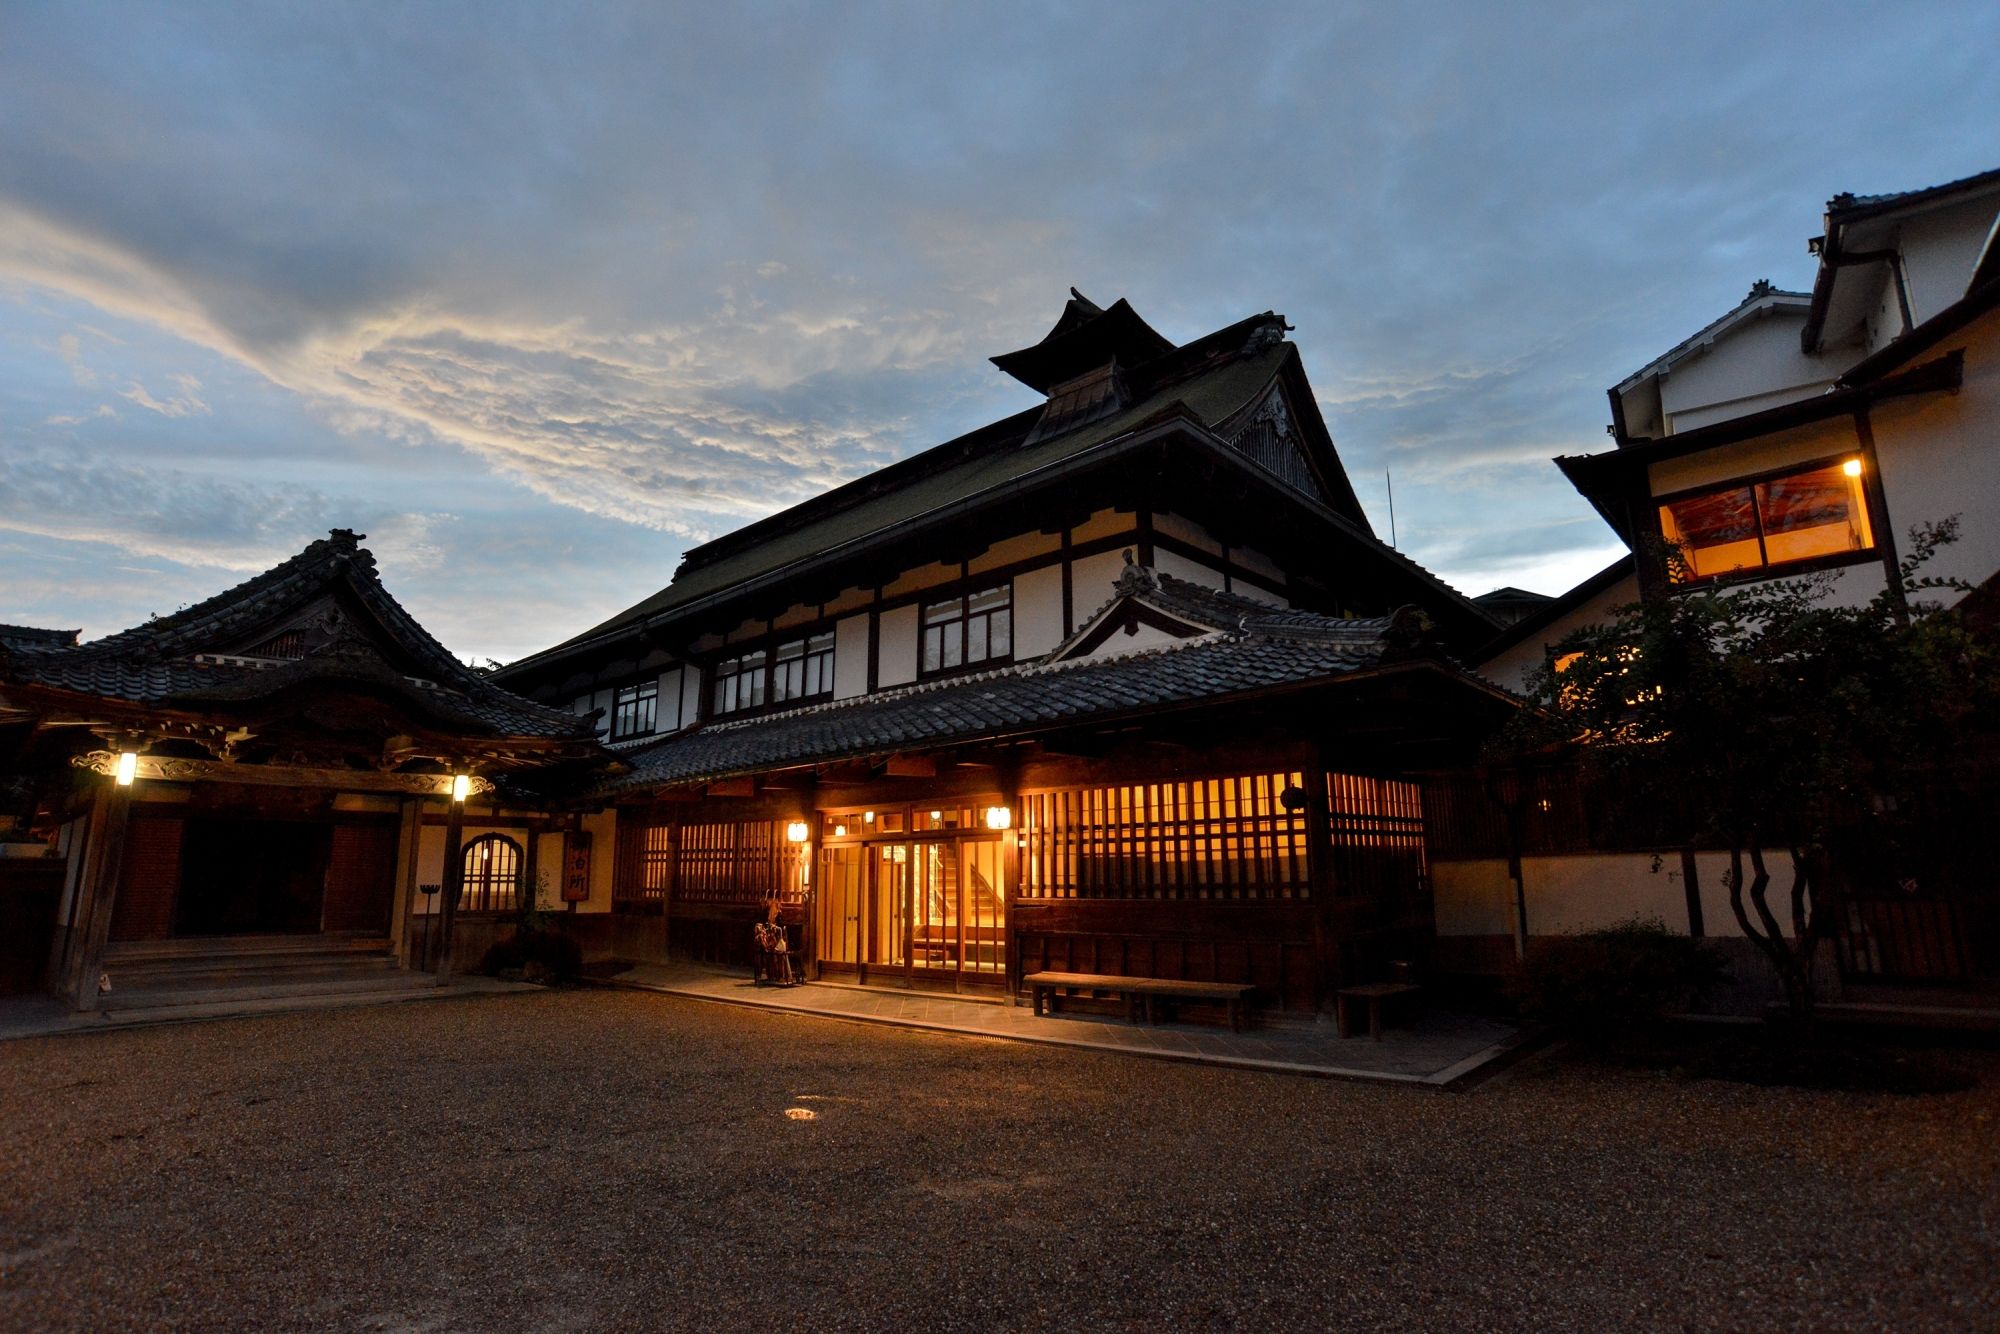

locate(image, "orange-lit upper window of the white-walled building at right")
[[1660, 458, 1874, 580]]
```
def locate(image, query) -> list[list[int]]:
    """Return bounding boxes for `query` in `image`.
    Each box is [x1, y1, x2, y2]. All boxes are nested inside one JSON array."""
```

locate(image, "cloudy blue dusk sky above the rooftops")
[[0, 0, 2000, 658]]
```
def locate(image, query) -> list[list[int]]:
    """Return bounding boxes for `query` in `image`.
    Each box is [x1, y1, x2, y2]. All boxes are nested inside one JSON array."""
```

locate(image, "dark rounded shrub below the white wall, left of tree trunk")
[[1512, 922, 1726, 1040]]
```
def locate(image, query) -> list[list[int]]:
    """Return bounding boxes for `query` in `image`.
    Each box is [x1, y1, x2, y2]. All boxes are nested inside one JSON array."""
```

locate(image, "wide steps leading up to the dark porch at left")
[[102, 936, 436, 1018]]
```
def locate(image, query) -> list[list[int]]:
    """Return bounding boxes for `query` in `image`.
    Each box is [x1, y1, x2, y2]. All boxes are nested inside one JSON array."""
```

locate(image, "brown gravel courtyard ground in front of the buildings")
[[0, 992, 2000, 1330]]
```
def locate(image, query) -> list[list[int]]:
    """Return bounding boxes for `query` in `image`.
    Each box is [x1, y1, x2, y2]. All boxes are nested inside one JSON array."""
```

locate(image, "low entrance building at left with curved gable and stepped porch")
[[0, 530, 608, 1008]]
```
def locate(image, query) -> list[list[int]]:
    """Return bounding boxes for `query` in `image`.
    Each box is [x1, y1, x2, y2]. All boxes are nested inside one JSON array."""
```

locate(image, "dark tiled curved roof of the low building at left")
[[0, 528, 592, 738]]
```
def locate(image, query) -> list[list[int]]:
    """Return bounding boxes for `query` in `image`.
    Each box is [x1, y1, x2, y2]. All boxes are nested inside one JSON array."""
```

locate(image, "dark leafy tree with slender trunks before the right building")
[[1490, 518, 1996, 1030]]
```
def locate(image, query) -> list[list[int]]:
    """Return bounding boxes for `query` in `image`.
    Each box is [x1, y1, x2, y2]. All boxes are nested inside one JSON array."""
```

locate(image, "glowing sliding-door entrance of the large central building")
[[814, 838, 1006, 990]]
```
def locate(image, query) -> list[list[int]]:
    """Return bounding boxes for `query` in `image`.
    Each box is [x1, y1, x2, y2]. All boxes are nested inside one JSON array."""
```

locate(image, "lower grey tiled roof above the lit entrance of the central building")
[[614, 572, 1440, 790]]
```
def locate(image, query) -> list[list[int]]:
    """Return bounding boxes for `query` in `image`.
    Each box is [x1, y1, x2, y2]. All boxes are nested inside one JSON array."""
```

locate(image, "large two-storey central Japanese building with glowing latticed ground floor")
[[496, 294, 1512, 1010]]
